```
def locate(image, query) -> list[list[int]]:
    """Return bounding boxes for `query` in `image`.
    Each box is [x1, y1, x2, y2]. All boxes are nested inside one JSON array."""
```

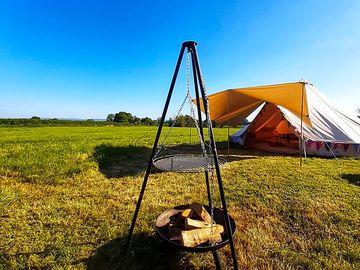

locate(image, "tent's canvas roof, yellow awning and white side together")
[[200, 82, 360, 143]]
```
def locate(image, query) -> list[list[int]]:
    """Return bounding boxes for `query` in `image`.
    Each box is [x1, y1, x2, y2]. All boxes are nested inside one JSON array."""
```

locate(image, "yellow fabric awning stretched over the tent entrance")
[[195, 82, 311, 126]]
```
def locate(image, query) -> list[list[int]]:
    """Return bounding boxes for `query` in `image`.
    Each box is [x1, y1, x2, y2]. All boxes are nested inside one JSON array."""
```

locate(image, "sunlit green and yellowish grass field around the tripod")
[[0, 127, 360, 269]]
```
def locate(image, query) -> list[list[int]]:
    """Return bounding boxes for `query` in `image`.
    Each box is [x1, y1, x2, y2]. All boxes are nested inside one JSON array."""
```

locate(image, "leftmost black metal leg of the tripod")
[[123, 44, 186, 253]]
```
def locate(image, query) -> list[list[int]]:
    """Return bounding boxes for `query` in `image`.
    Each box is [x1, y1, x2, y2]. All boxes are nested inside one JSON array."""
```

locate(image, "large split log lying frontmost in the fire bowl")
[[180, 225, 224, 247]]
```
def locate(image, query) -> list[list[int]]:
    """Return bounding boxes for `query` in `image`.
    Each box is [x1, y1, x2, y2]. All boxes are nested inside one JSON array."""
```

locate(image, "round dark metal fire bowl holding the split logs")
[[156, 204, 236, 252]]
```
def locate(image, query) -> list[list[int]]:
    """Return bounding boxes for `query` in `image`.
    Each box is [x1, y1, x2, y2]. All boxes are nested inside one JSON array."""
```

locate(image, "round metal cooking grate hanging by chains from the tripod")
[[153, 155, 226, 172]]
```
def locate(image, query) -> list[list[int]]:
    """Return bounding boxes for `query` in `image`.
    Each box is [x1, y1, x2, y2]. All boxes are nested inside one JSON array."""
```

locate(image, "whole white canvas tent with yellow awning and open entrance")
[[200, 82, 360, 156]]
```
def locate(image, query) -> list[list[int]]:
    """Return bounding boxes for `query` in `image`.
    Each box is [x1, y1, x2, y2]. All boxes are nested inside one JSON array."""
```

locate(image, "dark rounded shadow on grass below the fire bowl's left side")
[[85, 234, 188, 270]]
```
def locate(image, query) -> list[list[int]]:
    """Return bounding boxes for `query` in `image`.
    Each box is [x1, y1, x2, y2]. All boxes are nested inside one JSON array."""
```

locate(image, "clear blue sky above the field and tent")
[[0, 0, 360, 118]]
